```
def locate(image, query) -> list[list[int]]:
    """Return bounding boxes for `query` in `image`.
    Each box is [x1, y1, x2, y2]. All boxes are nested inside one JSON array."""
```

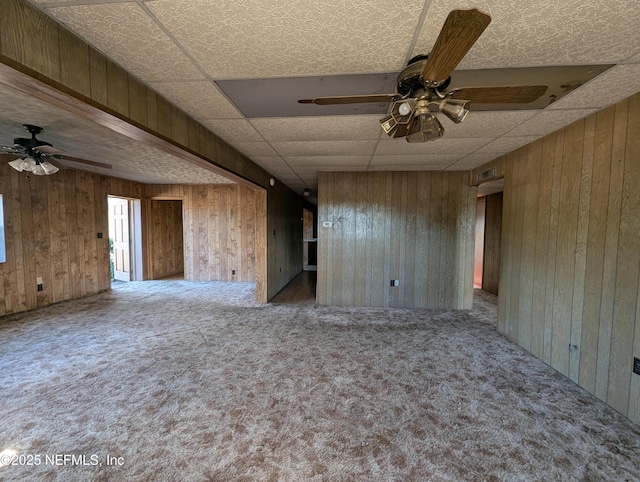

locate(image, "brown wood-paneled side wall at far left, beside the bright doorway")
[[0, 156, 110, 315]]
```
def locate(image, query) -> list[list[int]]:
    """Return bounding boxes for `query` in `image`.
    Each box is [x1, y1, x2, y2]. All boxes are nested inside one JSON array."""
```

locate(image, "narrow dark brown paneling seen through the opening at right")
[[482, 192, 503, 295]]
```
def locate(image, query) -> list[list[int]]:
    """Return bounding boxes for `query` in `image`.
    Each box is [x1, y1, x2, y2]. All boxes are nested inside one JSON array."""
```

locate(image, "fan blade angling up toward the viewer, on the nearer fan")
[[422, 8, 491, 85]]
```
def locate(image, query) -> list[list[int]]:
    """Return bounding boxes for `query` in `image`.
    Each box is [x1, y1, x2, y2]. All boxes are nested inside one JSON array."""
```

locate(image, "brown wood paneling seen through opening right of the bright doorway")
[[147, 200, 184, 279]]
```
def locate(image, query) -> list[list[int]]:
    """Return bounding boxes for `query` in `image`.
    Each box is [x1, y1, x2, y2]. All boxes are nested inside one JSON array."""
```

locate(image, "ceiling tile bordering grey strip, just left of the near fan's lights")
[[251, 115, 381, 141]]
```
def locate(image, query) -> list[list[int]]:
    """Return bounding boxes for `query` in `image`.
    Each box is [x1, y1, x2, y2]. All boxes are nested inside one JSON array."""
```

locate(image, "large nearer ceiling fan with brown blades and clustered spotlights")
[[298, 9, 547, 142]]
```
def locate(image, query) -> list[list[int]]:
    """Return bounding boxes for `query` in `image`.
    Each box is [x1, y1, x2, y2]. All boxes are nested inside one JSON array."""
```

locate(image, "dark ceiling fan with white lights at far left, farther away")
[[0, 124, 112, 176]]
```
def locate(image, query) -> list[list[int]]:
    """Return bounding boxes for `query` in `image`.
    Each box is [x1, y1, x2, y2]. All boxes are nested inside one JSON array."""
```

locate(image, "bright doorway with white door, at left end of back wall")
[[108, 196, 142, 281]]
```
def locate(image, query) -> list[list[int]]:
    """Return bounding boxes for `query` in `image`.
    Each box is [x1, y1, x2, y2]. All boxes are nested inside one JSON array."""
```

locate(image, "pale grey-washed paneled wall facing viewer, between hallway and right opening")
[[317, 171, 477, 308]]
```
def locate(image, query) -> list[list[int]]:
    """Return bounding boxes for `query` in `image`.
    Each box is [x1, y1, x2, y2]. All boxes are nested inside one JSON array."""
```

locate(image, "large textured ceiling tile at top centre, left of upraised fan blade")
[[146, 0, 424, 79]]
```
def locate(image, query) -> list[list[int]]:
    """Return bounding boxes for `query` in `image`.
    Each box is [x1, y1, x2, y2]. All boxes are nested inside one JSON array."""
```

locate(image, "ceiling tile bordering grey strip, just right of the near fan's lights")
[[438, 110, 539, 138]]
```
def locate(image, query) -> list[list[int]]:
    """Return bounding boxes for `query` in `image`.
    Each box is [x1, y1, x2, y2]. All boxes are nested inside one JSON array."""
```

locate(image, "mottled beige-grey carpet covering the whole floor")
[[0, 281, 640, 481]]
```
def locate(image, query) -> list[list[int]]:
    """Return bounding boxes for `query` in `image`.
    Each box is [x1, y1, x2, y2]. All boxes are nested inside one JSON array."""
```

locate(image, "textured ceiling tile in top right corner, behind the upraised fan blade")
[[414, 0, 640, 69]]
